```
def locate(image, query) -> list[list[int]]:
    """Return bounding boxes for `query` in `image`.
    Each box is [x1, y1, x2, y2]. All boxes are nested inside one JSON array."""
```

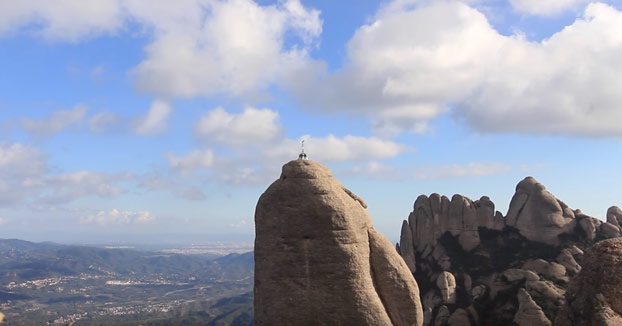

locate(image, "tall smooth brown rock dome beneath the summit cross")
[[254, 160, 423, 326]]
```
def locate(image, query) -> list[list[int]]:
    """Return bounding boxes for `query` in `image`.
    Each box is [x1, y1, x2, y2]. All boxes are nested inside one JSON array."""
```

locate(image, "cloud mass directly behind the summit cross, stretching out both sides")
[[188, 108, 413, 184]]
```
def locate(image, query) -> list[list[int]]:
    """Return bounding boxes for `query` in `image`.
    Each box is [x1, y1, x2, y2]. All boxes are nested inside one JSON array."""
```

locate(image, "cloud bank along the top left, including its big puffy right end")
[[0, 0, 322, 97]]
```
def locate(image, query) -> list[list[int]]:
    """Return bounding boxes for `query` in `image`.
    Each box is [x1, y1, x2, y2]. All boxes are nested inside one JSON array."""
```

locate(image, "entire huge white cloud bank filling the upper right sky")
[[288, 1, 622, 136]]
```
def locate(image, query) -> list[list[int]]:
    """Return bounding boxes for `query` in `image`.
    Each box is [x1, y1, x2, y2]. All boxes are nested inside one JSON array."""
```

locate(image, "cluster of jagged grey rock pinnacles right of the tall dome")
[[397, 177, 622, 325]]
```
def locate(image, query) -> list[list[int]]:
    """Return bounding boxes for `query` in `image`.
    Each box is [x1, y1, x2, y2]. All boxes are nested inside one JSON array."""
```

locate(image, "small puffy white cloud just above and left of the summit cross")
[[194, 107, 282, 146]]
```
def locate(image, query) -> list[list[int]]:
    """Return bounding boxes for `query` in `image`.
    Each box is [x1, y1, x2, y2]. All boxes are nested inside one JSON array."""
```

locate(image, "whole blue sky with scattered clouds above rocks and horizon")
[[0, 0, 622, 242]]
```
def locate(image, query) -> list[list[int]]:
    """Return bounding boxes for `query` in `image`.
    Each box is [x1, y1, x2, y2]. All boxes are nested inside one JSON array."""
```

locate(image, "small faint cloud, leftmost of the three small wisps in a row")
[[22, 105, 87, 136]]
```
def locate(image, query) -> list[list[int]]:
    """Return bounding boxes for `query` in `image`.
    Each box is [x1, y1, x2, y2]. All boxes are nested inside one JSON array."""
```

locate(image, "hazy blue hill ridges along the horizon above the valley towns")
[[0, 239, 253, 283]]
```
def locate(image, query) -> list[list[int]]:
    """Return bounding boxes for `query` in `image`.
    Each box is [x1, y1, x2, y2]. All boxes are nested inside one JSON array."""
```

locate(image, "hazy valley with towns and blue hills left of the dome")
[[0, 239, 254, 326]]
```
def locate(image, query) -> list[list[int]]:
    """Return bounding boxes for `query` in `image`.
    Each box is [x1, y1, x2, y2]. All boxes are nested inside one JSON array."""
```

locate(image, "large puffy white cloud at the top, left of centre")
[[134, 0, 321, 97]]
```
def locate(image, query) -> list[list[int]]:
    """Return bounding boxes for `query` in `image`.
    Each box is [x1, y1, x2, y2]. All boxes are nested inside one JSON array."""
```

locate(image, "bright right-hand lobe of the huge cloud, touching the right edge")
[[457, 3, 622, 136]]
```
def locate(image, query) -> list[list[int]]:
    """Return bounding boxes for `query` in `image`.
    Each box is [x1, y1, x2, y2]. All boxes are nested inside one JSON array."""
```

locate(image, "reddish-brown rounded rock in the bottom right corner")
[[555, 238, 622, 326]]
